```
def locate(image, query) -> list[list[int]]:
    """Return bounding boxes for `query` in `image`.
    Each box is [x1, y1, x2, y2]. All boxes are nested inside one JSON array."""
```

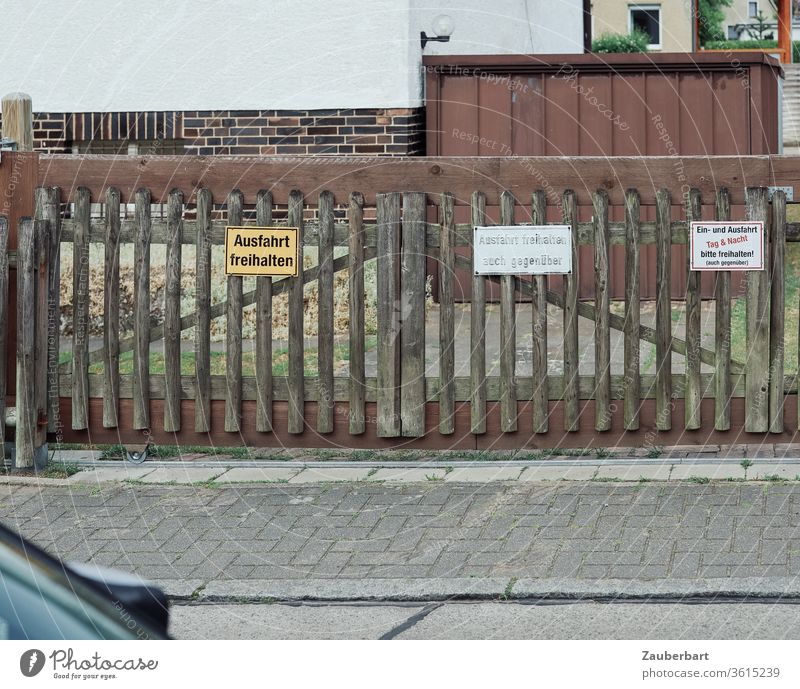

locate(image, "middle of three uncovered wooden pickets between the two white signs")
[[623, 189, 641, 431]]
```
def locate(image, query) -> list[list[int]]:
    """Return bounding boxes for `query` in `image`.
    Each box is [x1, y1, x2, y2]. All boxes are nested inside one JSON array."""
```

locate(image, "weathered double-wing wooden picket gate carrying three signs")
[[0, 156, 800, 449]]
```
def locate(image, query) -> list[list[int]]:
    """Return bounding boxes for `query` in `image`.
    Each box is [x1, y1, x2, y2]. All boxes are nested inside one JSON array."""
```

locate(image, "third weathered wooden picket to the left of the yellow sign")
[[133, 189, 150, 430]]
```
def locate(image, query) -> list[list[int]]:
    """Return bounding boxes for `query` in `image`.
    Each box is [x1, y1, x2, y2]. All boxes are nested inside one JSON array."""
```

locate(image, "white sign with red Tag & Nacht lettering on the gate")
[[689, 221, 764, 270]]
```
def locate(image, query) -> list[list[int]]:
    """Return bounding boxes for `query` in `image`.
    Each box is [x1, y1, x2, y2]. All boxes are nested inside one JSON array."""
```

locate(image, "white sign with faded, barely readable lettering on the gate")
[[472, 225, 572, 275]]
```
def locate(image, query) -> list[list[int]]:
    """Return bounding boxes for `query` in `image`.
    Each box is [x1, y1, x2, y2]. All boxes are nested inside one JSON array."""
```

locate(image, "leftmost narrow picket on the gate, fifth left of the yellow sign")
[[72, 187, 91, 430]]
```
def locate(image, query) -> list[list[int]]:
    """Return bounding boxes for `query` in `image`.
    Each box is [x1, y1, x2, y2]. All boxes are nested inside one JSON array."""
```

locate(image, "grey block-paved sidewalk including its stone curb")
[[0, 481, 800, 600]]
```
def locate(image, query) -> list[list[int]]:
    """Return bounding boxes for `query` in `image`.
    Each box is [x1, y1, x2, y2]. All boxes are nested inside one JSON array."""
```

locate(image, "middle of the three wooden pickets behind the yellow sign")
[[256, 189, 272, 433]]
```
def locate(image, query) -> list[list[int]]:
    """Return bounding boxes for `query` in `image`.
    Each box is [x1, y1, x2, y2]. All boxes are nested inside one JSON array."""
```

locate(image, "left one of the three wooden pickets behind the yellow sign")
[[225, 189, 244, 433]]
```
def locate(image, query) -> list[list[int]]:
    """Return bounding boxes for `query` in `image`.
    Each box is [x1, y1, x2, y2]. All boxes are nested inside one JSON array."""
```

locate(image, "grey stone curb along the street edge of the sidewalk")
[[188, 577, 800, 602]]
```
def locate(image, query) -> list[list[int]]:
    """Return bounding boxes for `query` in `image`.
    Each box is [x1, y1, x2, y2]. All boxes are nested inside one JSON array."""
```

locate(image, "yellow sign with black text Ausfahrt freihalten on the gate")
[[225, 225, 298, 277]]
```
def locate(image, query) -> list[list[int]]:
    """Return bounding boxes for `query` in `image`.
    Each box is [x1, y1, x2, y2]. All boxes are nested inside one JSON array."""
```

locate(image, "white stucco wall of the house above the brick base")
[[0, 0, 582, 112]]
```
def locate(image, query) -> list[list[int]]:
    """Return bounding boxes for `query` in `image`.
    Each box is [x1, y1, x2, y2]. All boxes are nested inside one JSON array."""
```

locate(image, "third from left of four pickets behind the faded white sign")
[[531, 189, 550, 433]]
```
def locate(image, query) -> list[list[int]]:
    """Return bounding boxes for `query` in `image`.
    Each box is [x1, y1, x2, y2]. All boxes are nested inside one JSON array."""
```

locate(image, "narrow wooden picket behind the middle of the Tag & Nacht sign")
[[714, 187, 731, 431]]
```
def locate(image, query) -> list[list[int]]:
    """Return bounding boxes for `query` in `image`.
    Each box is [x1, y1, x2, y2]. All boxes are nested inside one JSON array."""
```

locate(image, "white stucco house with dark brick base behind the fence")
[[0, 0, 584, 155]]
